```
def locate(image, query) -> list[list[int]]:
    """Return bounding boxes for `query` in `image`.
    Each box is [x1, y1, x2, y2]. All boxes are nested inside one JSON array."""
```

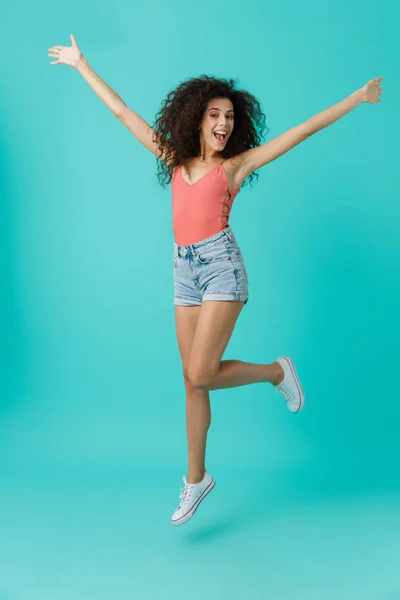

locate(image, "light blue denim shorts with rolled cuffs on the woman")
[[172, 227, 249, 306]]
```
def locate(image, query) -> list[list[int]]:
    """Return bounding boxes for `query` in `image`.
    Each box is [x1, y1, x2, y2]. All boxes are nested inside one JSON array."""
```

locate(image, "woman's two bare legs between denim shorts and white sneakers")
[[175, 302, 283, 483]]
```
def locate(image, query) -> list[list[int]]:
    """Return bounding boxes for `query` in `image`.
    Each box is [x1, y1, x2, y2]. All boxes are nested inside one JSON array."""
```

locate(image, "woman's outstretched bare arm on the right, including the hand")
[[236, 77, 383, 182]]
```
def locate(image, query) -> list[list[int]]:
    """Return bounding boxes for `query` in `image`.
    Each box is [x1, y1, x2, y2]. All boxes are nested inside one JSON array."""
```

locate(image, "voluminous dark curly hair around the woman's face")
[[152, 75, 269, 187]]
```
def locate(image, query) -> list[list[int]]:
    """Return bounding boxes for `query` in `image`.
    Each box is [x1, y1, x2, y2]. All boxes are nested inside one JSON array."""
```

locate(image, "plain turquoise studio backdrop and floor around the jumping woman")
[[0, 0, 400, 600]]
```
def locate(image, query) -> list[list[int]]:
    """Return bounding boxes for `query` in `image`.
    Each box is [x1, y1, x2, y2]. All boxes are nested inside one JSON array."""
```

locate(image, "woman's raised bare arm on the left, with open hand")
[[49, 35, 167, 156]]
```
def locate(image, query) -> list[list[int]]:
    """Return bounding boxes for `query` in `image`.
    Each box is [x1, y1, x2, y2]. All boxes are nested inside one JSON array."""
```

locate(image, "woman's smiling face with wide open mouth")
[[200, 98, 234, 156]]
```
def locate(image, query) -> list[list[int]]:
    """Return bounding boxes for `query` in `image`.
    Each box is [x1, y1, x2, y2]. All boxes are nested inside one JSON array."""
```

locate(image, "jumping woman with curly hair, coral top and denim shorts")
[[49, 35, 383, 525]]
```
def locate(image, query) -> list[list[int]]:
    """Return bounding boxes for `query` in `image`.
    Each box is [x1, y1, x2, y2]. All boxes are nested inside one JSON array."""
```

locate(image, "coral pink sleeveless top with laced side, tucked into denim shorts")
[[171, 164, 240, 246]]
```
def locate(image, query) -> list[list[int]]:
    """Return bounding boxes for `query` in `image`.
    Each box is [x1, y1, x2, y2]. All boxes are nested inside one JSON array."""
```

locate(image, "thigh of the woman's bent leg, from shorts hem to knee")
[[189, 300, 244, 380]]
